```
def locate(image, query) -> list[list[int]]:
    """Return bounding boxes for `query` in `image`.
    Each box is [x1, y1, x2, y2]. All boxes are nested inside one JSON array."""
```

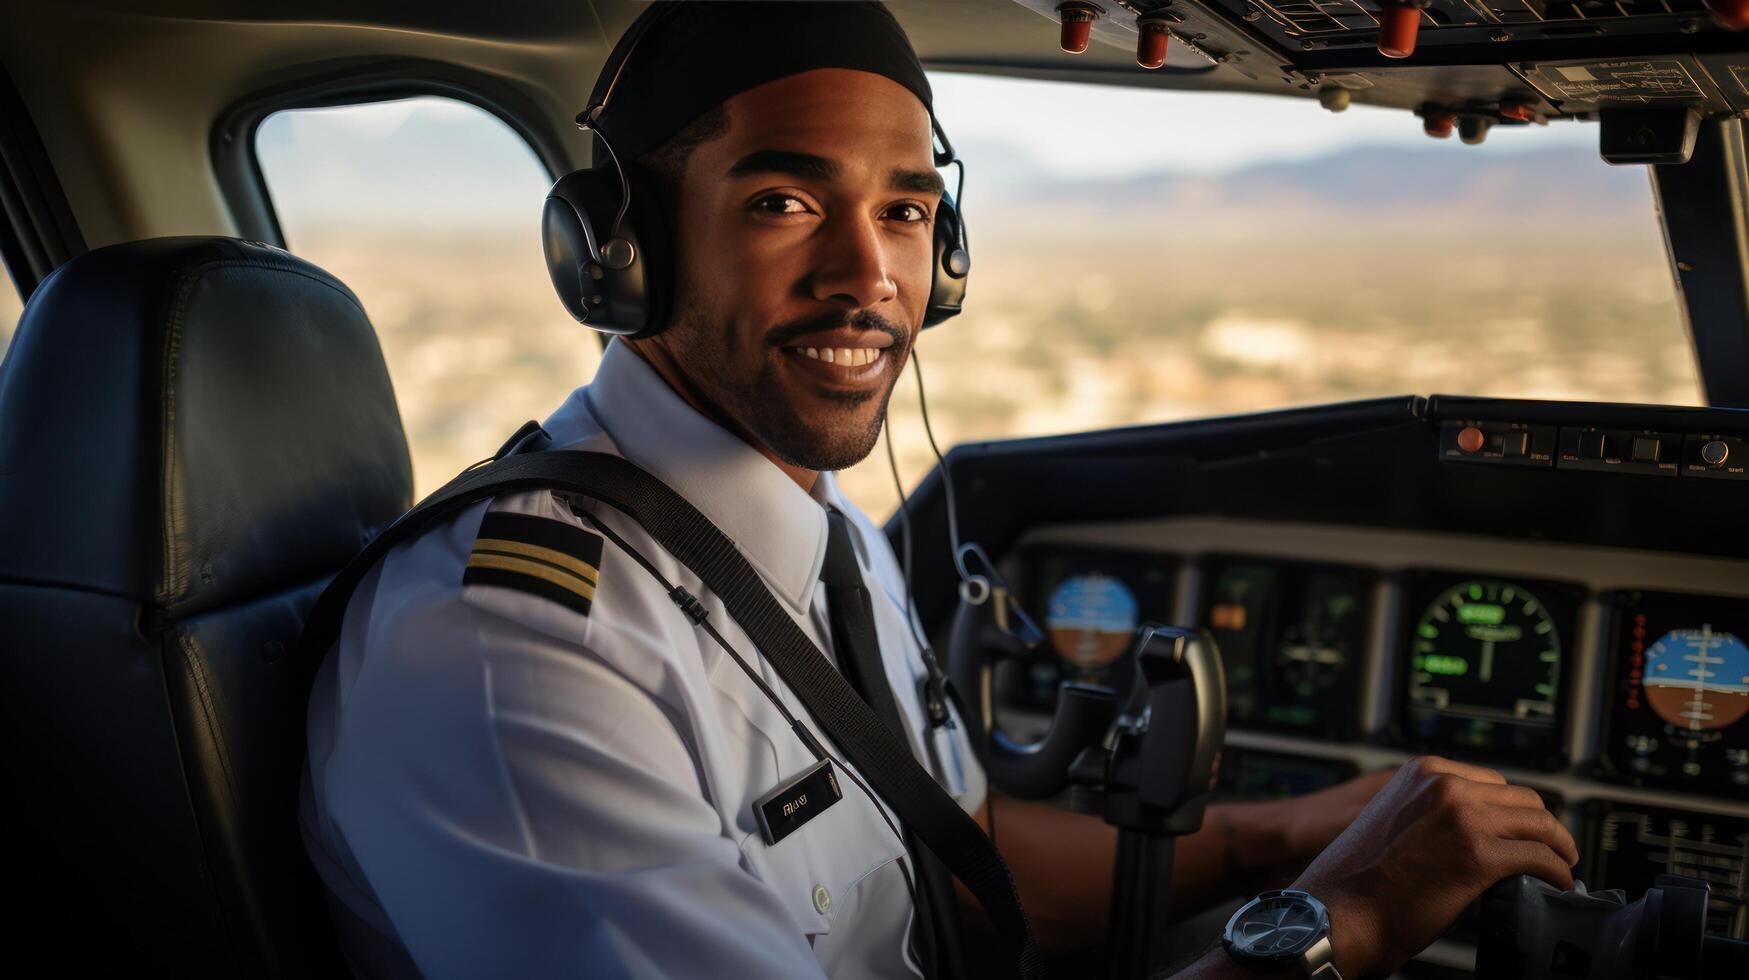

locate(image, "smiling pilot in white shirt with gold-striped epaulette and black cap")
[[301, 2, 1578, 978]]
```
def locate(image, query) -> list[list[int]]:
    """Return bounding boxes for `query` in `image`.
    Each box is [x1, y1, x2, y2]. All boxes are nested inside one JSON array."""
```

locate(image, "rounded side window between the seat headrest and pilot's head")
[[255, 98, 600, 495]]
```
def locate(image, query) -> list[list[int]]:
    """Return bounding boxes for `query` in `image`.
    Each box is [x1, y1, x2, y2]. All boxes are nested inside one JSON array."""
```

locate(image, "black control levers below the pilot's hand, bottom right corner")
[[1476, 875, 1749, 980]]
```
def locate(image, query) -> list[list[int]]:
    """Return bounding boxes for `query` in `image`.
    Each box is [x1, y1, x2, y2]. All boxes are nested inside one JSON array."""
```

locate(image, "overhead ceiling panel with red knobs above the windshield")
[[1014, 0, 1749, 118]]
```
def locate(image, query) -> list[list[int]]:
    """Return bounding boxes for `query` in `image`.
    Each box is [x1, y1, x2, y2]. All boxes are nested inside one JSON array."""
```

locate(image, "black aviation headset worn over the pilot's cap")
[[540, 4, 972, 340]]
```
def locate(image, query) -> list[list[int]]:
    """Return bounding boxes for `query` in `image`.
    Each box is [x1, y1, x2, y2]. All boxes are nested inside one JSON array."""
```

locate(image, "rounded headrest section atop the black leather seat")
[[0, 238, 413, 614]]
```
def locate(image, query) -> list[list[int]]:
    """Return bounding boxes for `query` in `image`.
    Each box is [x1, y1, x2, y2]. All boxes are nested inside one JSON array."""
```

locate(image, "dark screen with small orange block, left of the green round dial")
[[1198, 558, 1375, 739]]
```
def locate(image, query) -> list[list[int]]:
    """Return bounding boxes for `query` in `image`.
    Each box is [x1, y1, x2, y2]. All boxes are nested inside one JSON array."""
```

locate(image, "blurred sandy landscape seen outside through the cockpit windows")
[[0, 144, 1700, 516]]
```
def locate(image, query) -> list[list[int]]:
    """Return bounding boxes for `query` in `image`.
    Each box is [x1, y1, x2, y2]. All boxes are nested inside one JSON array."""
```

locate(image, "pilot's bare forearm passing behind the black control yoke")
[[979, 796, 1294, 949]]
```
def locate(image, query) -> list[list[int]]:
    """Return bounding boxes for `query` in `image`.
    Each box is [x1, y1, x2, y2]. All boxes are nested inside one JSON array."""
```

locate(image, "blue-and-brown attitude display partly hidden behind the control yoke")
[[1021, 546, 1177, 705]]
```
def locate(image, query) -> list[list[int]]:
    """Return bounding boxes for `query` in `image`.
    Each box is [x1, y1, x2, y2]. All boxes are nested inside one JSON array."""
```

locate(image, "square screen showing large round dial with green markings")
[[1399, 572, 1581, 768]]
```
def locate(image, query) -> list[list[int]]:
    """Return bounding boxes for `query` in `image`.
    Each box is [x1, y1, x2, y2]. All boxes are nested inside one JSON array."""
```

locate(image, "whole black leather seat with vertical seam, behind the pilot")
[[0, 238, 411, 977]]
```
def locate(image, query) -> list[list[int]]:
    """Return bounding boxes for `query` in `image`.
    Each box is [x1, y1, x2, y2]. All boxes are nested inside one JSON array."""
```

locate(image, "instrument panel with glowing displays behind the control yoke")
[[1020, 518, 1749, 945]]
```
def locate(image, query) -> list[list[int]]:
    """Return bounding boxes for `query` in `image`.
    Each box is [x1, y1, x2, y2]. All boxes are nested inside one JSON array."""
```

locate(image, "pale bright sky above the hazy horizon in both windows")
[[257, 72, 1597, 235]]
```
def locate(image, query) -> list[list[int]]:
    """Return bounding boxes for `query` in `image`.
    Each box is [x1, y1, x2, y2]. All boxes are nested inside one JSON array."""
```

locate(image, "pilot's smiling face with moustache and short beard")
[[651, 68, 941, 471]]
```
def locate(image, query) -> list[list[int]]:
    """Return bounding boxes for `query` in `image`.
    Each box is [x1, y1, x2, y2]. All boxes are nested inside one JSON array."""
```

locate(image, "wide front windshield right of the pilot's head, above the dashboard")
[[845, 74, 1702, 515]]
